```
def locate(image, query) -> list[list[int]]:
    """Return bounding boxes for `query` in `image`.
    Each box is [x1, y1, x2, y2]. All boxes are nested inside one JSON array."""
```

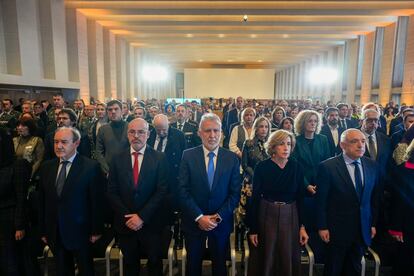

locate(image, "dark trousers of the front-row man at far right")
[[324, 242, 366, 276]]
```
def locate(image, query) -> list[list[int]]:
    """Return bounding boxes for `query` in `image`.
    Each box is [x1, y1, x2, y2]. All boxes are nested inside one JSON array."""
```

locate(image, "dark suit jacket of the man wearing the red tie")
[[108, 145, 168, 234]]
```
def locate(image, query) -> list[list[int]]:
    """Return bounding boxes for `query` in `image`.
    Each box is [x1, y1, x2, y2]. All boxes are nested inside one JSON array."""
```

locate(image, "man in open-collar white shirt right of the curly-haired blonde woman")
[[320, 107, 345, 157]]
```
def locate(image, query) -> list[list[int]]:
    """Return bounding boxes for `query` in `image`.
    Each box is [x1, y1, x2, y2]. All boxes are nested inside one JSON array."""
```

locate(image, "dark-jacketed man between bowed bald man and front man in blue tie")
[[171, 104, 201, 148]]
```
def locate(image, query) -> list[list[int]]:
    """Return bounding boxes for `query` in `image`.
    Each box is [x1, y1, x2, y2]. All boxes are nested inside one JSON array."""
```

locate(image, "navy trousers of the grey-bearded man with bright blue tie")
[[184, 233, 230, 276]]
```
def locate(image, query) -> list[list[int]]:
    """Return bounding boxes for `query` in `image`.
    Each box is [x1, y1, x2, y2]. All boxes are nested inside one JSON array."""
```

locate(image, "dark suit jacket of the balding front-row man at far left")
[[39, 154, 104, 249]]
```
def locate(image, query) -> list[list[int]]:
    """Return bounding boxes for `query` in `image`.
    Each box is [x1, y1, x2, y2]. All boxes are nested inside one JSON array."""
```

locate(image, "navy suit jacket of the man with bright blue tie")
[[179, 146, 241, 235]]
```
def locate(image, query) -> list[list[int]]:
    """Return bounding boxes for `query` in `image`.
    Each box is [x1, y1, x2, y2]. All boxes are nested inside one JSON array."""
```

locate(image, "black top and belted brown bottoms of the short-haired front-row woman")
[[247, 159, 304, 276]]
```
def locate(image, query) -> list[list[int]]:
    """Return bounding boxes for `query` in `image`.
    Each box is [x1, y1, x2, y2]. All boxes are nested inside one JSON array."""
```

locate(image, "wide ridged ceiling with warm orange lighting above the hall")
[[65, 0, 414, 69]]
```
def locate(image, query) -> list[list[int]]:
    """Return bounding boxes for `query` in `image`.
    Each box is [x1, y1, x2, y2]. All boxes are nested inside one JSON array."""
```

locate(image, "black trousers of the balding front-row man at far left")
[[51, 231, 95, 276]]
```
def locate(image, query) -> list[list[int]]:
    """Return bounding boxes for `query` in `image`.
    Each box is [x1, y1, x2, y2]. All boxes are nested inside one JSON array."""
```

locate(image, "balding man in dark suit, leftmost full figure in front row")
[[39, 127, 104, 275]]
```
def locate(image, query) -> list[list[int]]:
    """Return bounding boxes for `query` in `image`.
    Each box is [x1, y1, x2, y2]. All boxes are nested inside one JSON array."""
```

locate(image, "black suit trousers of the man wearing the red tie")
[[119, 228, 162, 276]]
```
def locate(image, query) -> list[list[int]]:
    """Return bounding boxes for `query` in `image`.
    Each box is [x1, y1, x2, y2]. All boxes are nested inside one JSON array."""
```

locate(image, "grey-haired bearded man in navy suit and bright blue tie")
[[179, 113, 241, 276]]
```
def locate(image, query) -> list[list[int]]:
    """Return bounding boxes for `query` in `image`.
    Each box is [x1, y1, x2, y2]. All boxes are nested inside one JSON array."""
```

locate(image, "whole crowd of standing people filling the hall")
[[0, 93, 414, 276]]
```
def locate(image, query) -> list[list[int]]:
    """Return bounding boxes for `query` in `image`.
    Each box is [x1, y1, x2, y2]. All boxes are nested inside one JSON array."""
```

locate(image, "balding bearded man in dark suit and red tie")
[[108, 118, 168, 276]]
